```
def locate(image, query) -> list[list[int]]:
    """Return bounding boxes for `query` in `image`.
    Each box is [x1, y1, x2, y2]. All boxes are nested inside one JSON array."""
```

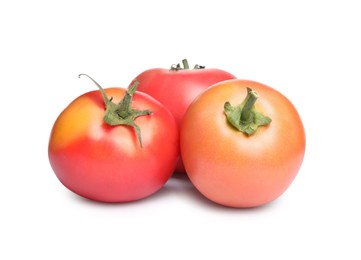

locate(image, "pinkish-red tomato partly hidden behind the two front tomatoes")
[[129, 60, 235, 173]]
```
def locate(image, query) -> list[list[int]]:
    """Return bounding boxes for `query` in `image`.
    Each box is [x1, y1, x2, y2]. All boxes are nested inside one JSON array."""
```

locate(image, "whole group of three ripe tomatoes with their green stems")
[[48, 60, 306, 208]]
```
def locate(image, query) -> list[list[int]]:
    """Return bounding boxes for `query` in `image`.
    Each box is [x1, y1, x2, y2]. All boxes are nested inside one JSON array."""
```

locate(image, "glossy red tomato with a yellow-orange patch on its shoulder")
[[48, 74, 179, 202]]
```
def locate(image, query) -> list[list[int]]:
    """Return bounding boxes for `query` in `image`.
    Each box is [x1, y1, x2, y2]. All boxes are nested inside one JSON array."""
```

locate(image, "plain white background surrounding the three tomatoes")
[[0, 0, 361, 259]]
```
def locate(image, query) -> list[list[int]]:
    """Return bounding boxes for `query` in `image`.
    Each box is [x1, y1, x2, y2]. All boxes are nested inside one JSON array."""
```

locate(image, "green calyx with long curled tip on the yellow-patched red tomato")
[[79, 74, 152, 148]]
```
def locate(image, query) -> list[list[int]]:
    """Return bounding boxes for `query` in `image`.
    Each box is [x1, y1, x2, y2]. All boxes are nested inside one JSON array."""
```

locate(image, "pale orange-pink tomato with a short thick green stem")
[[180, 80, 306, 207]]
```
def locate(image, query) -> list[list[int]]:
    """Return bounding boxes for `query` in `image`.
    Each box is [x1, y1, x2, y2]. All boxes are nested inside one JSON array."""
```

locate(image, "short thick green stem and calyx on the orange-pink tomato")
[[224, 88, 272, 136]]
